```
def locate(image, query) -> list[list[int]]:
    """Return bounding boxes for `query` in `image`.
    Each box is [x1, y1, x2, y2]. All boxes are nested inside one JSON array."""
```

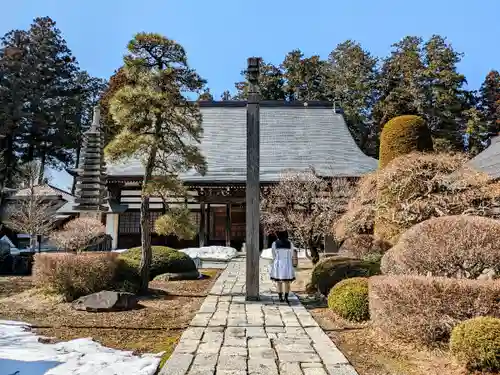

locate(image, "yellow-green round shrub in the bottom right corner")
[[450, 316, 500, 371]]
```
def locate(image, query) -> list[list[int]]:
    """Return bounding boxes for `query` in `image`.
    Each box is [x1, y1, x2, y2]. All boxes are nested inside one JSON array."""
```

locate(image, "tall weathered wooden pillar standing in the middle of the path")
[[246, 57, 260, 301]]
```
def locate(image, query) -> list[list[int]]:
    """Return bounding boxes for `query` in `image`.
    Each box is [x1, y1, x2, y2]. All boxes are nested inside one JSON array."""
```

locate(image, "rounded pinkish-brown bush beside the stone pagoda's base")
[[50, 217, 106, 251]]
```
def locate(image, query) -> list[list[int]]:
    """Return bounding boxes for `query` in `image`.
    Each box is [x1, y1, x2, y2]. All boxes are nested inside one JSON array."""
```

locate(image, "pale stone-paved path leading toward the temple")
[[160, 257, 357, 375]]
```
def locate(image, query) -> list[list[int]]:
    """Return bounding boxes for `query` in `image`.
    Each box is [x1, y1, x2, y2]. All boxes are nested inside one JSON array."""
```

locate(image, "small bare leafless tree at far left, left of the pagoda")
[[5, 162, 56, 251]]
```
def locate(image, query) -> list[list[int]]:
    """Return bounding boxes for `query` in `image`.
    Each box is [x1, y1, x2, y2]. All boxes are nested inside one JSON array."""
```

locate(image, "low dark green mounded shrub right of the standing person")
[[308, 257, 380, 296]]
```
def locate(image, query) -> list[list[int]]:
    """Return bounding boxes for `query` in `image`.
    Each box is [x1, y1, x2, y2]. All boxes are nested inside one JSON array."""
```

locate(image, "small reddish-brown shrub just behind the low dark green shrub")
[[339, 234, 391, 259]]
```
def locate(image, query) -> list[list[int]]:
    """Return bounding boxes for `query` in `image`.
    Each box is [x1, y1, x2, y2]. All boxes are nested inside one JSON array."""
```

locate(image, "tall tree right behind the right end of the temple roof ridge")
[[327, 40, 378, 156]]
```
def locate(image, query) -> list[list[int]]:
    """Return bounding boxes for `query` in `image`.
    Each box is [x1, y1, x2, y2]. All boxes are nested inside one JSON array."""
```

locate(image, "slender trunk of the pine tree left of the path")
[[139, 145, 158, 294]]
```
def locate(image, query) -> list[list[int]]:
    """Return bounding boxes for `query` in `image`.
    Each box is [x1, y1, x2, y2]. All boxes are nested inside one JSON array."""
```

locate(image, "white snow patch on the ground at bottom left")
[[0, 320, 162, 375]]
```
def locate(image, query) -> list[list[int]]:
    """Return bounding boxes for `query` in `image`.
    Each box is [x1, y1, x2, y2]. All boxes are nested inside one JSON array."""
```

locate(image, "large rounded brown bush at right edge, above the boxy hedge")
[[381, 215, 500, 279]]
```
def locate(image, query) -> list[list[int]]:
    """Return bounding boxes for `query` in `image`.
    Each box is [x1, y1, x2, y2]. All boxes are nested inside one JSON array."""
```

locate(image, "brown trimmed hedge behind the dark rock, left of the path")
[[33, 252, 118, 301]]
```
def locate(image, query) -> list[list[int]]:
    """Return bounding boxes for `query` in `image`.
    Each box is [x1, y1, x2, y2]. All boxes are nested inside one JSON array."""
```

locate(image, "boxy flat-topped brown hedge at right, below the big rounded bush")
[[369, 276, 500, 345]]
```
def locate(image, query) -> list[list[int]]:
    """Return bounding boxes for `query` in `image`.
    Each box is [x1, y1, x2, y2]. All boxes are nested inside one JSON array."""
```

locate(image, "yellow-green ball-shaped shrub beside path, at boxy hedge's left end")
[[328, 277, 370, 322]]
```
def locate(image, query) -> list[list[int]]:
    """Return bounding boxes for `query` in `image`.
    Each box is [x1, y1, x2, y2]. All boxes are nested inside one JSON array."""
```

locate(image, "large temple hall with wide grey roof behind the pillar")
[[99, 101, 377, 248]]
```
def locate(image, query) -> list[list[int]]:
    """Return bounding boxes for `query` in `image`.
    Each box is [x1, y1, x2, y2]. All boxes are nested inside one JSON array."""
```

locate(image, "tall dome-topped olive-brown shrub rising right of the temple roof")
[[379, 115, 433, 168]]
